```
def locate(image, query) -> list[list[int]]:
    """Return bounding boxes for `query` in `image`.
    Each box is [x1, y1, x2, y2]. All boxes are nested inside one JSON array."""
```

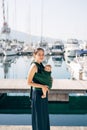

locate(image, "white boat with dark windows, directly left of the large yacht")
[[51, 41, 64, 55]]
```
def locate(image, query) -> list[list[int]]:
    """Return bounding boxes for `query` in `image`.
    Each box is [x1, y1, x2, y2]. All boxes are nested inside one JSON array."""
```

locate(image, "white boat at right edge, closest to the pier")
[[69, 51, 87, 80]]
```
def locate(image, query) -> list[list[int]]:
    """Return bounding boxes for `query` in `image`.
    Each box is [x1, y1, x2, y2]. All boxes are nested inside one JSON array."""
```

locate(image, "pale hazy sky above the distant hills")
[[0, 0, 87, 39]]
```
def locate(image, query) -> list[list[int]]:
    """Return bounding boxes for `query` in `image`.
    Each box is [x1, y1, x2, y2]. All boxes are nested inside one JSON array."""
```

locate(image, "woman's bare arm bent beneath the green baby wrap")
[[27, 64, 48, 89]]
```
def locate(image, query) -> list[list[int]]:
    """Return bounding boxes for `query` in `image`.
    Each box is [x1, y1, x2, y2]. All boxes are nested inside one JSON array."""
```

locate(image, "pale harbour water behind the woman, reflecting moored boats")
[[0, 55, 70, 79]]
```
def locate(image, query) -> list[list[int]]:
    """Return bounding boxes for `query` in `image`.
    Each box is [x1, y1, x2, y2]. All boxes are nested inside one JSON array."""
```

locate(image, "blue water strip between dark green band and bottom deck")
[[0, 114, 87, 126]]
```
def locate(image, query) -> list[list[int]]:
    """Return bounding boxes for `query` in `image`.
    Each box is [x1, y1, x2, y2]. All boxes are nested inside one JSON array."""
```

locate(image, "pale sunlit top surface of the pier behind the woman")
[[0, 79, 87, 92]]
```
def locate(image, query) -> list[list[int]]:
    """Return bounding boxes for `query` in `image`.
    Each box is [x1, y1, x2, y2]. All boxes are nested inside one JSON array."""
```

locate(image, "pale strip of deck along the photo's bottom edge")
[[0, 126, 87, 130]]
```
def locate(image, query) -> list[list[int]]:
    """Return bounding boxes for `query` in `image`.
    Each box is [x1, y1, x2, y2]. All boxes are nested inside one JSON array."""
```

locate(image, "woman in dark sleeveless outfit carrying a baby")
[[27, 48, 50, 130]]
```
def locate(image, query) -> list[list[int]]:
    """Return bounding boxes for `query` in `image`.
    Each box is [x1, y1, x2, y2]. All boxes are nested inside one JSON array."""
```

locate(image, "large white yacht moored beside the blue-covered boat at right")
[[64, 39, 80, 57]]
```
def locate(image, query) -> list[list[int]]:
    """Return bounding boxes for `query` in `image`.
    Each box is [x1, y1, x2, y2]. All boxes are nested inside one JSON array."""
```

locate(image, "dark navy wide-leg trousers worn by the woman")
[[31, 88, 50, 130]]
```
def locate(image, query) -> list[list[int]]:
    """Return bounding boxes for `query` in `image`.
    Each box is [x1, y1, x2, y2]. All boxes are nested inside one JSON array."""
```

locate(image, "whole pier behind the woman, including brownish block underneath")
[[0, 79, 87, 101]]
